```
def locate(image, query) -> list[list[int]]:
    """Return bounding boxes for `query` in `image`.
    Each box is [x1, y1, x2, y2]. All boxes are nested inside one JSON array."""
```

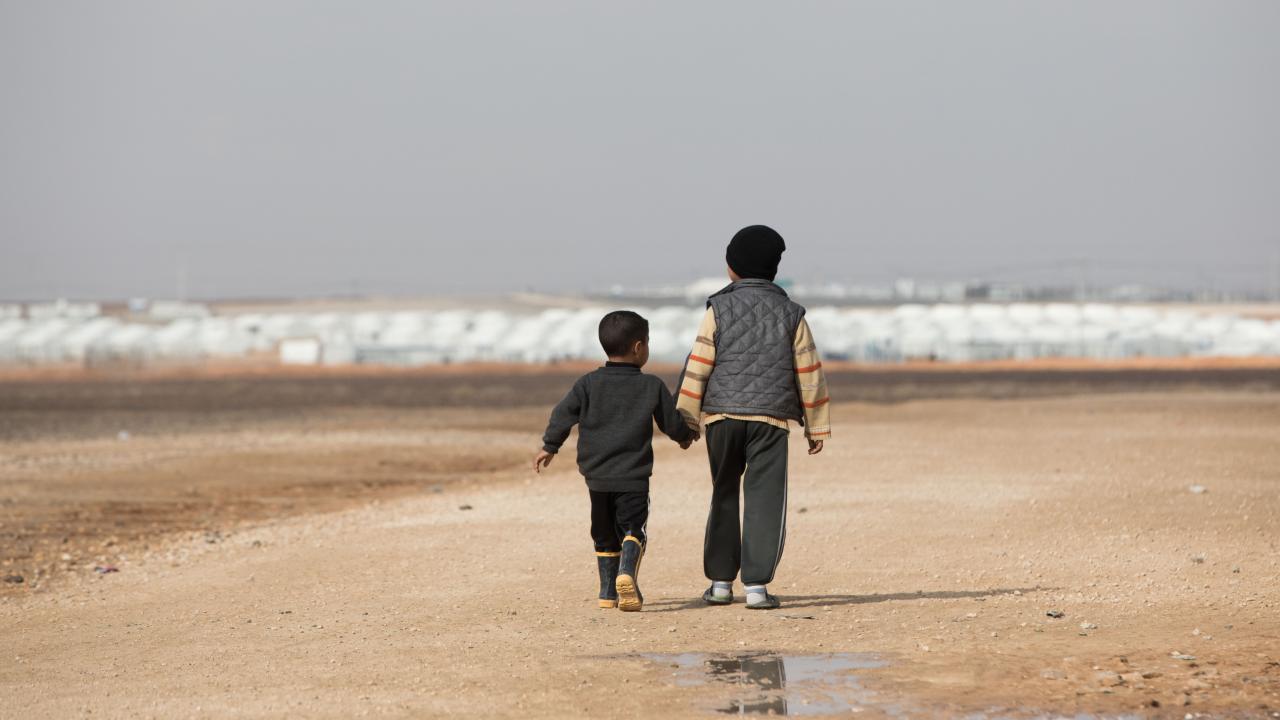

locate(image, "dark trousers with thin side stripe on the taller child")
[[703, 419, 787, 585]]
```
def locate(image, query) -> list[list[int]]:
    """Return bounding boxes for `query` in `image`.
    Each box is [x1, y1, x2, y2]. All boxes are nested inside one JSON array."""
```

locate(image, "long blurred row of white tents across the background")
[[0, 304, 1280, 365]]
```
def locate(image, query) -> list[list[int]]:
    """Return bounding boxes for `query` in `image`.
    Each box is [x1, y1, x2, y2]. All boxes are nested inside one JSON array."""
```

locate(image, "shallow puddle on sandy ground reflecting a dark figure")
[[643, 652, 897, 715]]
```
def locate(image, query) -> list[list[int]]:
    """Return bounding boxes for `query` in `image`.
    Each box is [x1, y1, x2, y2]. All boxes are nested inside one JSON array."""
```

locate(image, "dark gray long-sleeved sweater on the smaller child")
[[543, 363, 694, 492]]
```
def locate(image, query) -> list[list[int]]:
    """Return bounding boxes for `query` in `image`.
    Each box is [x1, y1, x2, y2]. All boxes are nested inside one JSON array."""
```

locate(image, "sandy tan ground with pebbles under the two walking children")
[[0, 377, 1280, 717]]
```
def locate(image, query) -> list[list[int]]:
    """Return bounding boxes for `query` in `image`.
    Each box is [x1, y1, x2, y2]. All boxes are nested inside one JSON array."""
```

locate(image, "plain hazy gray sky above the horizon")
[[0, 0, 1280, 299]]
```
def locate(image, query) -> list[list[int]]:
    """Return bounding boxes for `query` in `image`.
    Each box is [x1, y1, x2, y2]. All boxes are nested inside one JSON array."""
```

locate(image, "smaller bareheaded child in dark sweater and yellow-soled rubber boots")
[[534, 310, 698, 612]]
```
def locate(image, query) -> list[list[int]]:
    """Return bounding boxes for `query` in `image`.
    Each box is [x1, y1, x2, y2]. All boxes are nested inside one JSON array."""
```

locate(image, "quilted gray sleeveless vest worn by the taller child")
[[703, 278, 804, 421]]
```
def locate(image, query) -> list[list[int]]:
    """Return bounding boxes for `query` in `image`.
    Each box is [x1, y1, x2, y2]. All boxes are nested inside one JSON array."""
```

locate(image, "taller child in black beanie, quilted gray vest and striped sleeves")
[[677, 225, 831, 610]]
